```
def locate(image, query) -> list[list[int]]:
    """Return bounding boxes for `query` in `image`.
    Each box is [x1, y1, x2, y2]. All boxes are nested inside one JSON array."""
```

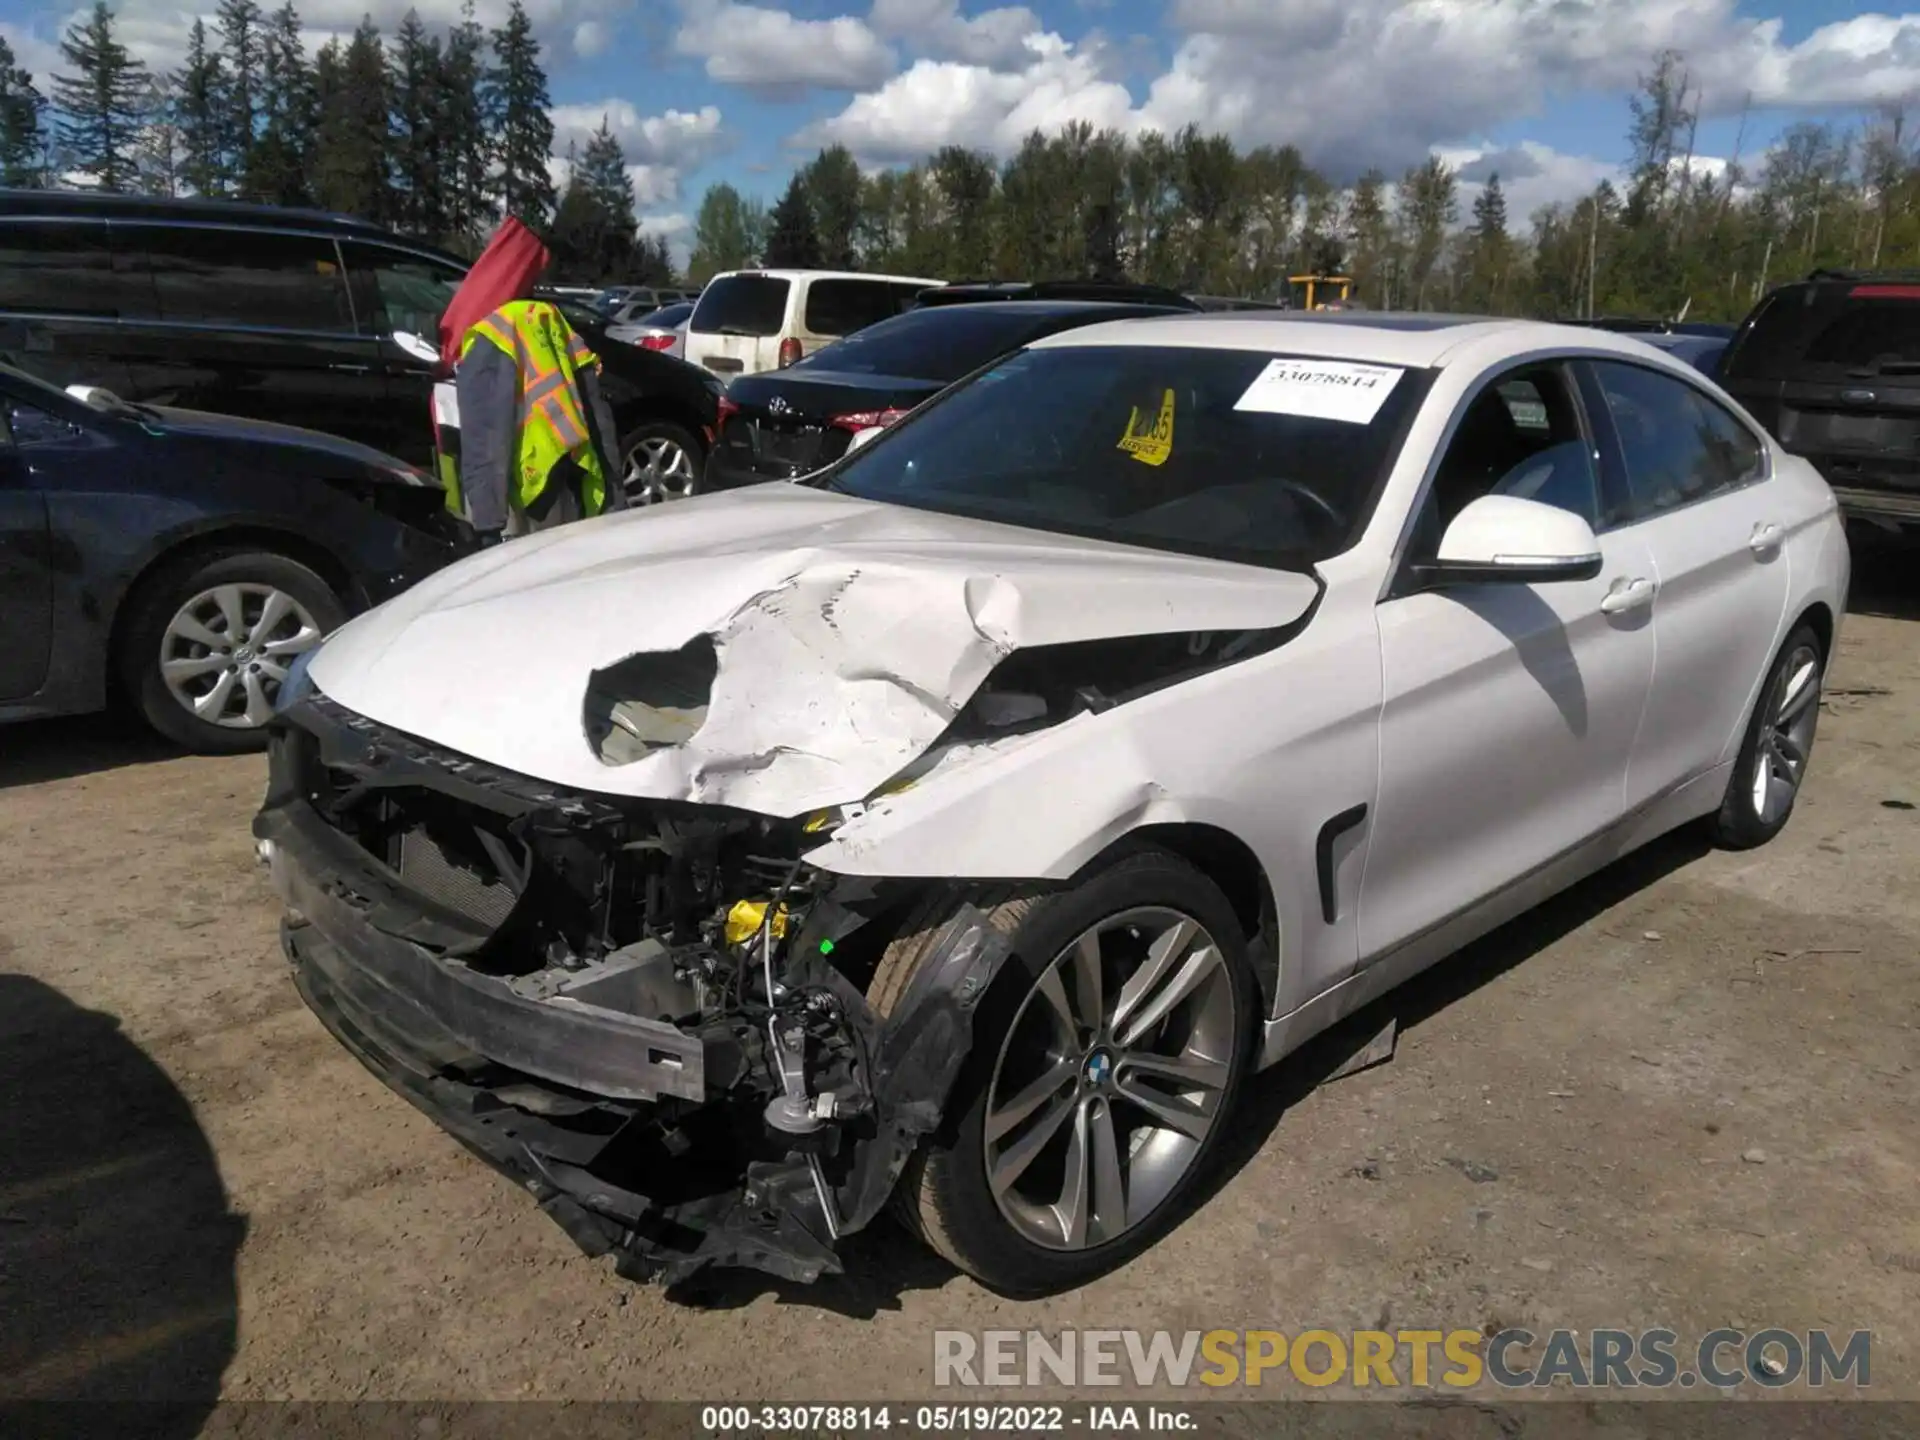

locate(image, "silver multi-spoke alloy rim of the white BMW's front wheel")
[[985, 906, 1240, 1250]]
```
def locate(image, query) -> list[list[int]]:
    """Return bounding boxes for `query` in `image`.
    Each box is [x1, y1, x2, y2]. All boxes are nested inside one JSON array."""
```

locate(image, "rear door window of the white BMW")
[[1594, 361, 1766, 518]]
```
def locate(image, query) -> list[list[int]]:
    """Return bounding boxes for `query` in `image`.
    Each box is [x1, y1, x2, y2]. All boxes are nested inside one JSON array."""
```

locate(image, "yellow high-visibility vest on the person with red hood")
[[461, 300, 607, 515]]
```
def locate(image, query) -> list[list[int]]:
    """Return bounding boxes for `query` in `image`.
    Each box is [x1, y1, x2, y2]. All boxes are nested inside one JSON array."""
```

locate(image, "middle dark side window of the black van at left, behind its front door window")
[[113, 225, 353, 334]]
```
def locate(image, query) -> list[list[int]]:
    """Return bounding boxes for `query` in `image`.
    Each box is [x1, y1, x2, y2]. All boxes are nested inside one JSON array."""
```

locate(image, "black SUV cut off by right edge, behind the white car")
[[1720, 271, 1920, 528]]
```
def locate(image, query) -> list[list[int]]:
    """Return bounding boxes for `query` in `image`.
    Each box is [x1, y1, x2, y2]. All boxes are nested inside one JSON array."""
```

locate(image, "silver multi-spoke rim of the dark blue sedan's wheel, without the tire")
[[159, 584, 321, 730]]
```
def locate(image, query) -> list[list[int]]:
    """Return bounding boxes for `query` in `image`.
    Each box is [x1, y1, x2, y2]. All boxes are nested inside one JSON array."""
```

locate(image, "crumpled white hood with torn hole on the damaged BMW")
[[311, 484, 1317, 816]]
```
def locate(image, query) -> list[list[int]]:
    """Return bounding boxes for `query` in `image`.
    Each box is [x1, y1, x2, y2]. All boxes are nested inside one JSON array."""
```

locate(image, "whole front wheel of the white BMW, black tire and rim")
[[868, 851, 1258, 1296]]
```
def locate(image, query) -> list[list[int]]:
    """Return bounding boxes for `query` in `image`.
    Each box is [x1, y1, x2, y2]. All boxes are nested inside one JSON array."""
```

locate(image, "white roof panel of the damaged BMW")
[[1033, 311, 1704, 369]]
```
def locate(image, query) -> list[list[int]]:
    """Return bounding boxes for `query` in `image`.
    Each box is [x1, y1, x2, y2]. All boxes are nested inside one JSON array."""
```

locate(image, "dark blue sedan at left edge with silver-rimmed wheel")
[[0, 367, 470, 753]]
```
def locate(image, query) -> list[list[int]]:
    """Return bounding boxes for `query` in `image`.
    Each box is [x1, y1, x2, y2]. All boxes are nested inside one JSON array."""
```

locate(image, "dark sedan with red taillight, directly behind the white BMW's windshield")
[[707, 300, 1190, 490]]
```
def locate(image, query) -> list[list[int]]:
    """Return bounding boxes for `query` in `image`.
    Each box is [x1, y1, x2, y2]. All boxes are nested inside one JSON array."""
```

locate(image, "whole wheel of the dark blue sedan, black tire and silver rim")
[[115, 549, 348, 755]]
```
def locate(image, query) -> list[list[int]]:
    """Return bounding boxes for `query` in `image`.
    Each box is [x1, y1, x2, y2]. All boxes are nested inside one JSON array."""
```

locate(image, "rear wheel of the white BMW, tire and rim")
[[1713, 624, 1826, 851]]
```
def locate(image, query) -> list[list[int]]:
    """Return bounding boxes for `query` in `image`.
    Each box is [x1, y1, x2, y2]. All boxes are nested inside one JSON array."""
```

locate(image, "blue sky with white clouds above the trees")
[[11, 0, 1920, 248]]
